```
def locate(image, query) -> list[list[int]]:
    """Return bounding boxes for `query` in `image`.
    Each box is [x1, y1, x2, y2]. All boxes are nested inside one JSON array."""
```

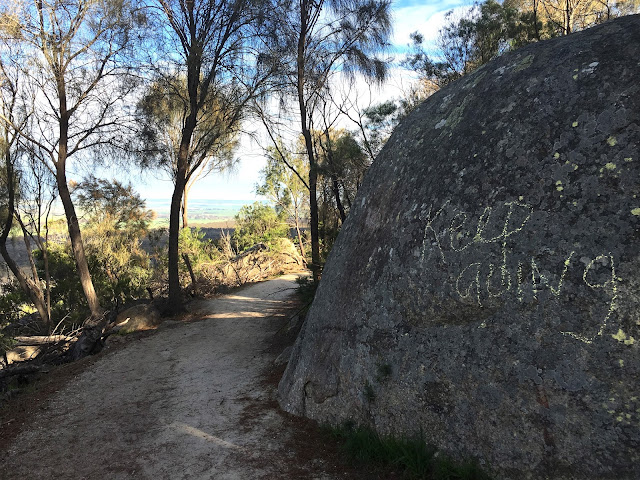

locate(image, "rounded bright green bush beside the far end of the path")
[[233, 202, 289, 251]]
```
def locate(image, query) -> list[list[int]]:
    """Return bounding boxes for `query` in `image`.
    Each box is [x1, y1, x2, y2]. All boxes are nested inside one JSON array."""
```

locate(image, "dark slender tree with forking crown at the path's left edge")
[[145, 0, 268, 311]]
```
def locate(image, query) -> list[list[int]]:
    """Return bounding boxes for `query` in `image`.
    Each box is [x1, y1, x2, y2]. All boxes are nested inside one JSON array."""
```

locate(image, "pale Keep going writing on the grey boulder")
[[419, 200, 619, 343]]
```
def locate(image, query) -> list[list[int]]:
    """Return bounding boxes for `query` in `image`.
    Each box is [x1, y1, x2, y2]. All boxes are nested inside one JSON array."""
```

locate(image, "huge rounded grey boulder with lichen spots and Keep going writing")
[[279, 16, 640, 479]]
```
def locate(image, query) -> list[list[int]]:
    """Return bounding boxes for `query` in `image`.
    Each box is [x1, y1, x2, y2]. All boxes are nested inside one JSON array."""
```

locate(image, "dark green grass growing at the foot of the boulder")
[[330, 423, 491, 480]]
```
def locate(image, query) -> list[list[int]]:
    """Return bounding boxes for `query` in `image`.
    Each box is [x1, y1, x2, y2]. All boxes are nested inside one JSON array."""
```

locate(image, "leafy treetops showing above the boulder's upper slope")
[[403, 0, 638, 97]]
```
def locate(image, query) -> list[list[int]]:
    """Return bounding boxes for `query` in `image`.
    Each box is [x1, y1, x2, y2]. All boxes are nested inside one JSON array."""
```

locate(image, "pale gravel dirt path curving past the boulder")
[[0, 275, 368, 480]]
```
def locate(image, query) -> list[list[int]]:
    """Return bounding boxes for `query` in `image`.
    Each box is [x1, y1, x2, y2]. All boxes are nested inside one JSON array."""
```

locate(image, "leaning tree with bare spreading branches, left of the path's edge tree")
[[0, 0, 142, 336]]
